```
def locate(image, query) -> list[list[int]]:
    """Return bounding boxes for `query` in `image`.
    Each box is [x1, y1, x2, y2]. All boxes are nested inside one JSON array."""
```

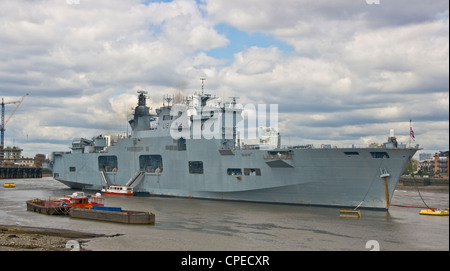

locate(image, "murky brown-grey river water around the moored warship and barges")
[[0, 178, 449, 251]]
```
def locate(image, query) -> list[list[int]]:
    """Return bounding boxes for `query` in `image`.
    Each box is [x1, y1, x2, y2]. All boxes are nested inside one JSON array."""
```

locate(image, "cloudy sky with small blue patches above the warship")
[[0, 0, 449, 157]]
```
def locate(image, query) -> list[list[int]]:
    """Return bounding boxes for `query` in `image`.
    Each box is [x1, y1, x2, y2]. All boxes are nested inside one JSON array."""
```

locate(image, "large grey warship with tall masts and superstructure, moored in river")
[[49, 87, 418, 210]]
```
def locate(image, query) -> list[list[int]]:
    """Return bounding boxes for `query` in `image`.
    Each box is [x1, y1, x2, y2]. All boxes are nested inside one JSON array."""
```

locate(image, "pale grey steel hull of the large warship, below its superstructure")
[[53, 140, 416, 209]]
